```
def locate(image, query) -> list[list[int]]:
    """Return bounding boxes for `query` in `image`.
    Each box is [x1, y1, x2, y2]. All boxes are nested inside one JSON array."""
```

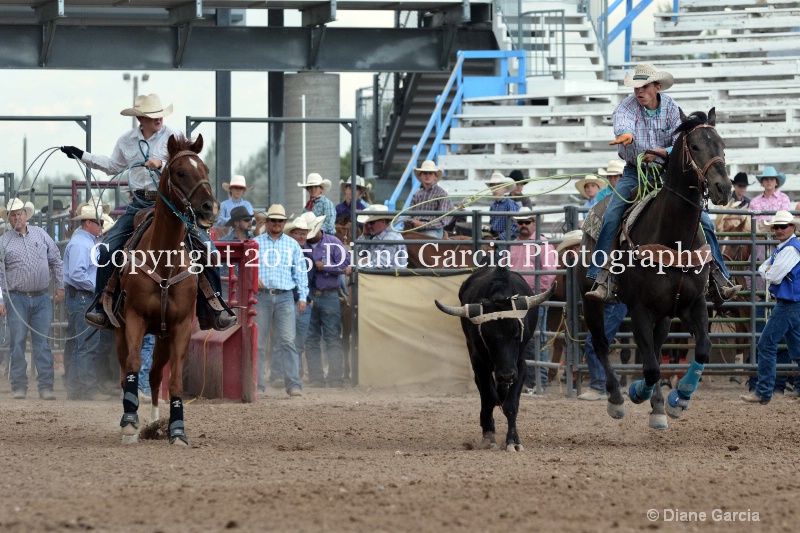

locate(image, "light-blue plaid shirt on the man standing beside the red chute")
[[253, 233, 310, 301]]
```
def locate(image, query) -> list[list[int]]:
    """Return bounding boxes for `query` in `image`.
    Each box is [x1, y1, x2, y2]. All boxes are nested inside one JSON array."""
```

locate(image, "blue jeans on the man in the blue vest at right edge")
[[755, 300, 800, 399]]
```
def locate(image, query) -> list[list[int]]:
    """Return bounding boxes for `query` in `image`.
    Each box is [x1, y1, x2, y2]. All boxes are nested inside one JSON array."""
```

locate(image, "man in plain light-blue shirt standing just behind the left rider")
[[64, 203, 108, 400]]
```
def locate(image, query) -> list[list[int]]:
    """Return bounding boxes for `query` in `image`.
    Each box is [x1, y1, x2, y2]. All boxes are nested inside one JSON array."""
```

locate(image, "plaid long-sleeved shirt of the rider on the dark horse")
[[613, 93, 681, 166]]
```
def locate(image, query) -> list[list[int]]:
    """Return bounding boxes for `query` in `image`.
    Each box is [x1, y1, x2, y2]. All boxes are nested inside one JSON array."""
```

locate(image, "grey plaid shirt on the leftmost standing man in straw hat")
[[0, 225, 64, 292]]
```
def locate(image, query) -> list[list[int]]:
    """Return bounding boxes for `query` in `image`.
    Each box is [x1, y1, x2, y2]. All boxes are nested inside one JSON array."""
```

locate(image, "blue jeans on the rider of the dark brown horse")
[[586, 164, 730, 279]]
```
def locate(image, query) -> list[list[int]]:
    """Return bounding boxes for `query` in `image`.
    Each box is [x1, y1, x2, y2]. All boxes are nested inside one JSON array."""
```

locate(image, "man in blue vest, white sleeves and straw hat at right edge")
[[740, 211, 800, 405]]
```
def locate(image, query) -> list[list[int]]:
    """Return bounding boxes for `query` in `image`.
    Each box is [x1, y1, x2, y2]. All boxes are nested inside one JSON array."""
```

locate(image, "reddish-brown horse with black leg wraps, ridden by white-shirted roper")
[[117, 135, 219, 446]]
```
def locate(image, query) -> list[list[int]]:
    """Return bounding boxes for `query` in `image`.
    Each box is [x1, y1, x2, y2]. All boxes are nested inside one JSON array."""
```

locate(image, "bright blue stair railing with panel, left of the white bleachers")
[[384, 50, 526, 209]]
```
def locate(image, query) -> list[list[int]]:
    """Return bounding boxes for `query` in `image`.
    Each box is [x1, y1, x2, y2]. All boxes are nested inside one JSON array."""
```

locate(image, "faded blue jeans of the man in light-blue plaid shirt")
[[255, 291, 303, 392]]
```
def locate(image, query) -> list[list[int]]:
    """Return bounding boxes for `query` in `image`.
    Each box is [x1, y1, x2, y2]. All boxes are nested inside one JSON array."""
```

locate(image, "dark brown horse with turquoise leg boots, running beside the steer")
[[578, 108, 731, 429]]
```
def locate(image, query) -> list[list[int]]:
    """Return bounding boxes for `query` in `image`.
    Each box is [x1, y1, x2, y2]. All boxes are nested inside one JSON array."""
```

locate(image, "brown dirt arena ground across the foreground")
[[0, 377, 800, 532]]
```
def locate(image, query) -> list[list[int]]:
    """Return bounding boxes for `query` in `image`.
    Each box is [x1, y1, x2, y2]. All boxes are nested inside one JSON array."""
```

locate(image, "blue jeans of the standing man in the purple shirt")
[[306, 291, 344, 385]]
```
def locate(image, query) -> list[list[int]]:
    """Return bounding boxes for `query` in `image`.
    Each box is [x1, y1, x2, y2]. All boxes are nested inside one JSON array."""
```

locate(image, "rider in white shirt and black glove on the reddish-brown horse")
[[61, 94, 236, 330]]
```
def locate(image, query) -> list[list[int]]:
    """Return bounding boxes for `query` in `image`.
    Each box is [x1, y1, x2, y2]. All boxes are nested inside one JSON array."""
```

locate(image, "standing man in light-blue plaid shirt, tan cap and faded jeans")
[[253, 204, 308, 396]]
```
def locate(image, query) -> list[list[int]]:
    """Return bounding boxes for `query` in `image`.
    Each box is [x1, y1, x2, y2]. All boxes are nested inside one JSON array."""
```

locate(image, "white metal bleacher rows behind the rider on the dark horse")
[[424, 0, 800, 203]]
